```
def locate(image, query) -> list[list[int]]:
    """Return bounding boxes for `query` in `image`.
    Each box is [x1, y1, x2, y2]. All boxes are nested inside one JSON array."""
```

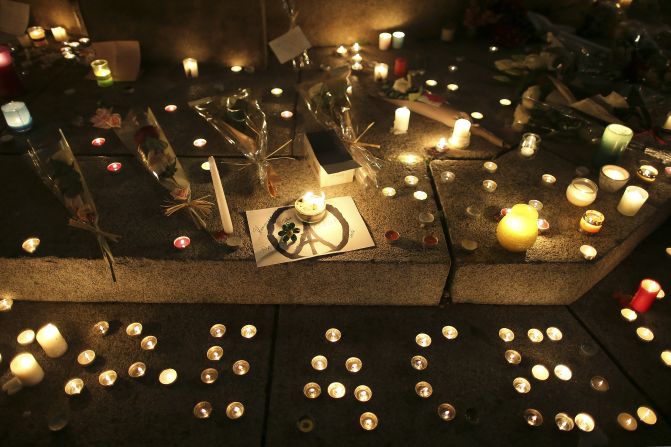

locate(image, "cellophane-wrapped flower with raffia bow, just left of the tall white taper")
[[114, 108, 213, 230]]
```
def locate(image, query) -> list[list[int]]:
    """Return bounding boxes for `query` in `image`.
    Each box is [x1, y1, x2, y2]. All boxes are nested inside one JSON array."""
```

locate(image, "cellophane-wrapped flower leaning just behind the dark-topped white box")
[[299, 65, 382, 188]]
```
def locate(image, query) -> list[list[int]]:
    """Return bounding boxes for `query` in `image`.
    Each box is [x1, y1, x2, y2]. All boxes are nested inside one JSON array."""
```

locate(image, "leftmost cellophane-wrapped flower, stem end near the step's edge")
[[28, 129, 120, 281]]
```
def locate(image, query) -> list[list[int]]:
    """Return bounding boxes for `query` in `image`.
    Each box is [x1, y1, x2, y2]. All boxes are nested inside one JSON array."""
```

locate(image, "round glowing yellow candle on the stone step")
[[496, 204, 538, 252]]
